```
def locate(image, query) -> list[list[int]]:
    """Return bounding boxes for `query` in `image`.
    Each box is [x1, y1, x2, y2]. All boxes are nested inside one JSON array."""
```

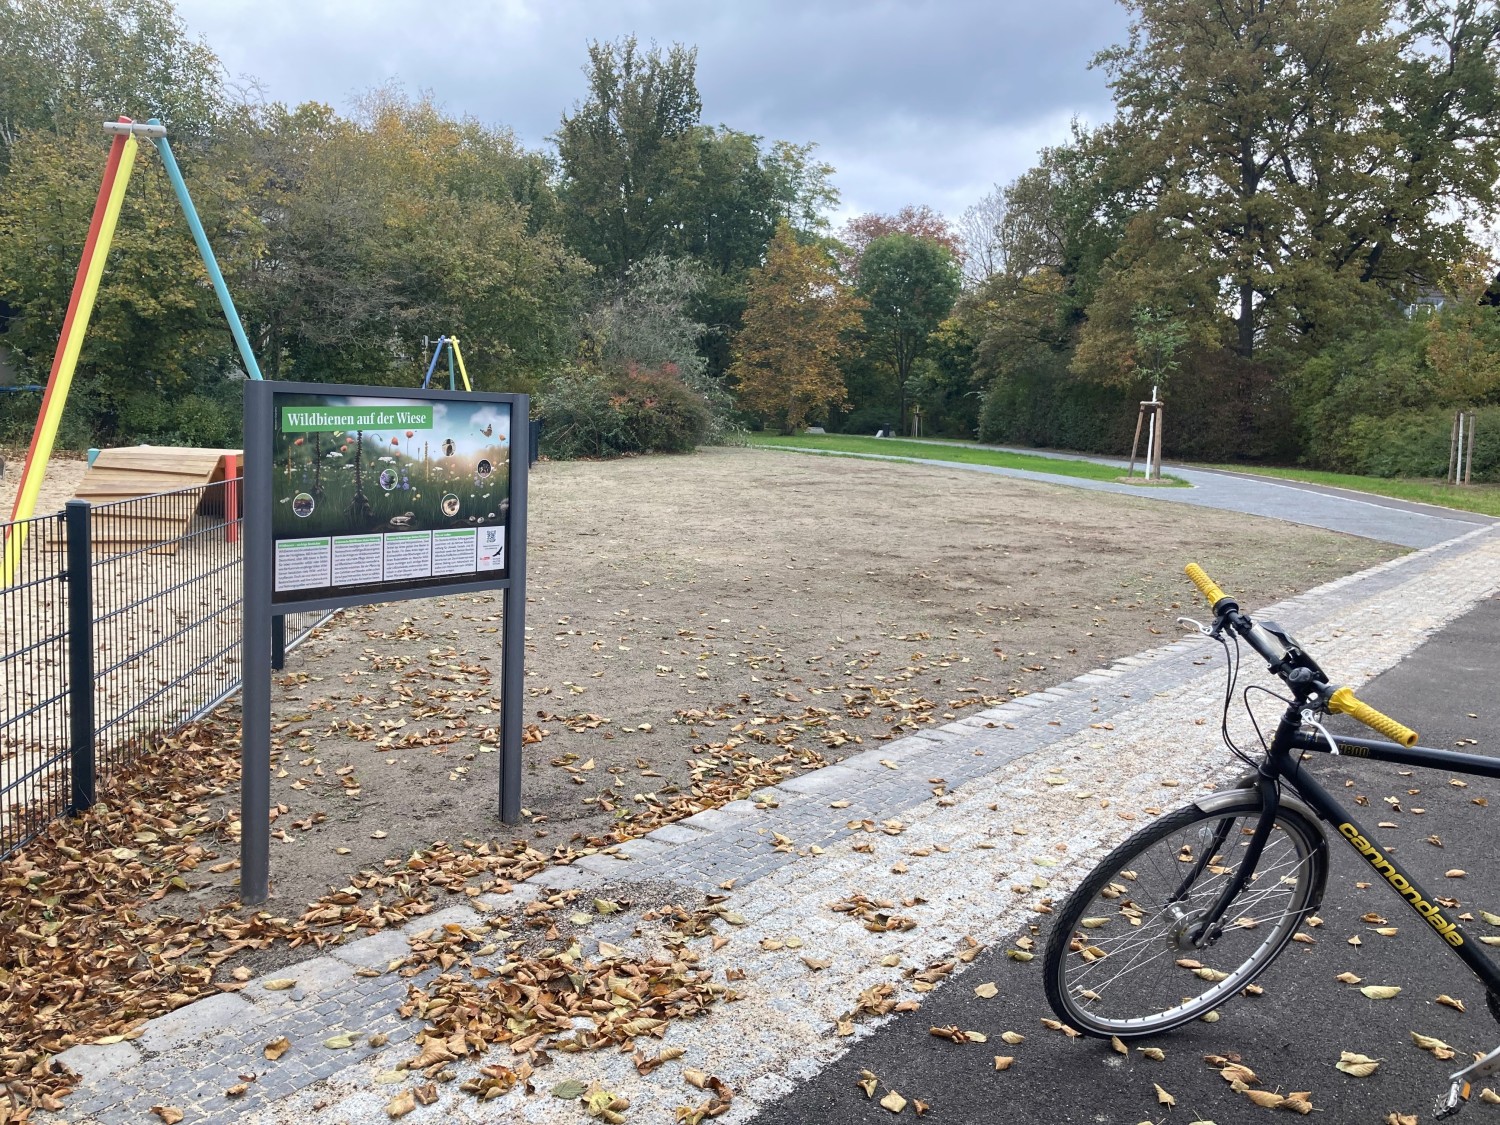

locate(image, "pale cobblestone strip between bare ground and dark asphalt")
[[39, 528, 1500, 1125]]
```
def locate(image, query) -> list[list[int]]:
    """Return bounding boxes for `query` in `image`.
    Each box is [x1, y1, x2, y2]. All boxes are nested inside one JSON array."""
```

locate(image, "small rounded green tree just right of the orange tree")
[[857, 233, 959, 429]]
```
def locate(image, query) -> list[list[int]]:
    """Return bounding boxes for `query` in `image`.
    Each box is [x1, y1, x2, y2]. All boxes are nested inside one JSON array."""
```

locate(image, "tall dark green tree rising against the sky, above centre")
[[557, 36, 702, 279]]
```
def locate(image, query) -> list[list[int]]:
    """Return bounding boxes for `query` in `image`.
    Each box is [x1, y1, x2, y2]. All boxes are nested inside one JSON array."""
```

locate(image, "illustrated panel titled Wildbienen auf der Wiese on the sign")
[[272, 393, 510, 593]]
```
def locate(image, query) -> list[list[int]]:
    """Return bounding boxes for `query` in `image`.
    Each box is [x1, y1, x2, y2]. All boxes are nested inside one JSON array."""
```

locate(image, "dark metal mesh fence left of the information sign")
[[0, 480, 327, 855]]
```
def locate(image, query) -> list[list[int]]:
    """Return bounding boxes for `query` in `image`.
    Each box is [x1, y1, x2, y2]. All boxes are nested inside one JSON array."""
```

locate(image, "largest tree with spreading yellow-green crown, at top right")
[[1088, 0, 1500, 360]]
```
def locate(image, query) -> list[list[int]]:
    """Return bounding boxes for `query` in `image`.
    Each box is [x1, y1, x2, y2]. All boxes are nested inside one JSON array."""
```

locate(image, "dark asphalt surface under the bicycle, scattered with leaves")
[[756, 597, 1500, 1125]]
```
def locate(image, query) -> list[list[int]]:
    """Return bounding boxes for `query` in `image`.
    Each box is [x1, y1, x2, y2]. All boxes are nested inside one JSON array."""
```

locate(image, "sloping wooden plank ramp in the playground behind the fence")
[[74, 446, 243, 555]]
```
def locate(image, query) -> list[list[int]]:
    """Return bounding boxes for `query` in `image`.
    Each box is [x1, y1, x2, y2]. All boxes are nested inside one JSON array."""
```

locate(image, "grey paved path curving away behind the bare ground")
[[768, 443, 1500, 558]]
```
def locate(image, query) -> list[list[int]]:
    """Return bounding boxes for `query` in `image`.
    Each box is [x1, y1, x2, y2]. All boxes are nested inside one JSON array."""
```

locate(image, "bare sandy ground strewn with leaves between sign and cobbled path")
[[149, 449, 1400, 912]]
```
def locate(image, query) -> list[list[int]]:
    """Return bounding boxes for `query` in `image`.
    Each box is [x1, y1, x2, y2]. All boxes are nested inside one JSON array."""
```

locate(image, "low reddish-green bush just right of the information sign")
[[537, 365, 711, 461]]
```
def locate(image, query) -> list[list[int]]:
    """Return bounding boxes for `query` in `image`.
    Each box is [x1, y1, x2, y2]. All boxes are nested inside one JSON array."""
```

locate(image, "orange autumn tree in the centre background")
[[729, 222, 860, 434]]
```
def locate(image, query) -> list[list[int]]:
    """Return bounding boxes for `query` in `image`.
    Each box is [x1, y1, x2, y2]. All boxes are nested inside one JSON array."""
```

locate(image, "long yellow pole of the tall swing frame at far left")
[[0, 135, 140, 587]]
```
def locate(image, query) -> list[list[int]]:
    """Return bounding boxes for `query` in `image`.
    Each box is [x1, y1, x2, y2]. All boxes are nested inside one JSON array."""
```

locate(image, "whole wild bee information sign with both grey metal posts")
[[240, 383, 531, 903]]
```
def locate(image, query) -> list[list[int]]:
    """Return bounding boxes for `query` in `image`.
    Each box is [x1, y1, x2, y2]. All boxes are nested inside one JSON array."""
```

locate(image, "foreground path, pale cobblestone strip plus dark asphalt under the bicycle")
[[39, 528, 1500, 1125]]
